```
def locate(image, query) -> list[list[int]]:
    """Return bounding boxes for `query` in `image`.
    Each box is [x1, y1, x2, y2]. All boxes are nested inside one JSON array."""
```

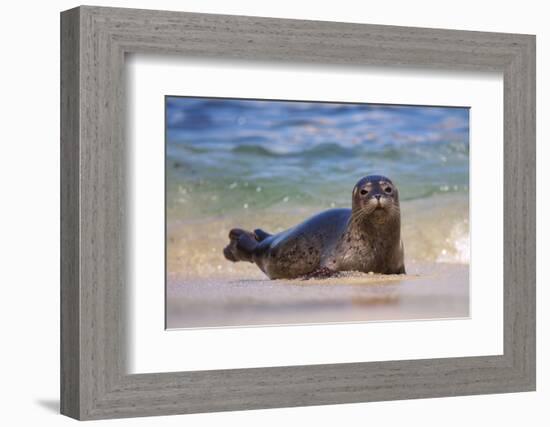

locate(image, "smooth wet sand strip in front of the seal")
[[166, 262, 469, 328]]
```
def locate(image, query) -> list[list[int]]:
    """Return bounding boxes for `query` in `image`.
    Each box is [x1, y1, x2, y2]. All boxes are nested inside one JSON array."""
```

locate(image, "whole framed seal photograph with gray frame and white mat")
[[61, 6, 536, 420]]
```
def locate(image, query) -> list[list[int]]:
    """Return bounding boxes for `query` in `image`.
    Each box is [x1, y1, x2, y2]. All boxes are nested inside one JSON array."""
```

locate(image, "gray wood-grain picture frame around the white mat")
[[61, 6, 535, 419]]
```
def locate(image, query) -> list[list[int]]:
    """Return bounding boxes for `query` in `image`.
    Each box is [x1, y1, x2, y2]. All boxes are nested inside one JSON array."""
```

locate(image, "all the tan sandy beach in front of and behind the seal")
[[166, 195, 469, 328]]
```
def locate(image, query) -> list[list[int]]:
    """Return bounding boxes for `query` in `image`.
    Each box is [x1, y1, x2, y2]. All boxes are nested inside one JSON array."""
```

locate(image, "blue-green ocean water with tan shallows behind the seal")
[[166, 97, 469, 274]]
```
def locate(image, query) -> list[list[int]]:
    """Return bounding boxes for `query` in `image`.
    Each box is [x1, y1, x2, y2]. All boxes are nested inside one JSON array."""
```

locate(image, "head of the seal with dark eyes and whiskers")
[[352, 175, 400, 224]]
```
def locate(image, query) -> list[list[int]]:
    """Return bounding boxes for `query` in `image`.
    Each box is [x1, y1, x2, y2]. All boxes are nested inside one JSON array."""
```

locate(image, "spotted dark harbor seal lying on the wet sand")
[[223, 175, 405, 279]]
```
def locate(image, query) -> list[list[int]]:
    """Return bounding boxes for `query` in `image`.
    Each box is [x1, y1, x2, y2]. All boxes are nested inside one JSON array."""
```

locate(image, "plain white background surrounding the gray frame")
[[0, 0, 550, 427]]
